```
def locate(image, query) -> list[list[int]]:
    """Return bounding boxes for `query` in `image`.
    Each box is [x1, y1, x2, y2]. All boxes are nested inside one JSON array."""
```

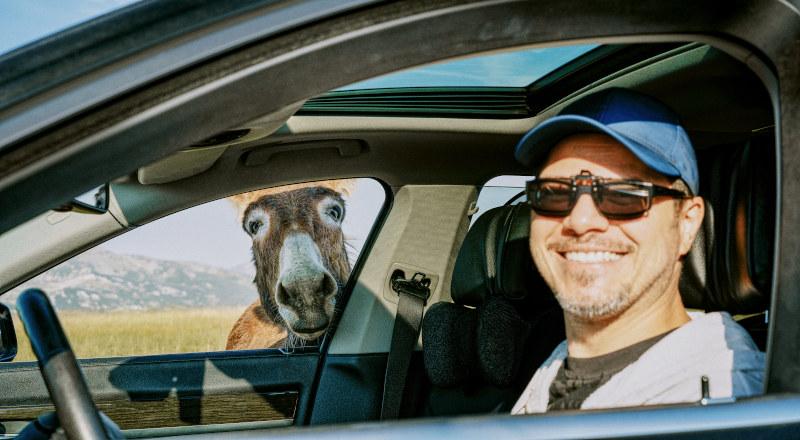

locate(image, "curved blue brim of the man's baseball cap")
[[514, 115, 681, 177]]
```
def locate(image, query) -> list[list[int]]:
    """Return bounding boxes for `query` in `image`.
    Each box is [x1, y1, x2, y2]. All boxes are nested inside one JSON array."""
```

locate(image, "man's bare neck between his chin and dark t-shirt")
[[564, 286, 691, 358]]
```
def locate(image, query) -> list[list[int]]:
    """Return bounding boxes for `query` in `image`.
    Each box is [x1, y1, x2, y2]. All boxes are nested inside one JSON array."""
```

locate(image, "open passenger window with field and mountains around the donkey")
[[2, 179, 385, 362]]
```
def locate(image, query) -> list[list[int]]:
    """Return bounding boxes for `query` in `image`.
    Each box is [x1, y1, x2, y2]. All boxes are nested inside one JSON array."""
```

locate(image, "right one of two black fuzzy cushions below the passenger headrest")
[[477, 297, 530, 386]]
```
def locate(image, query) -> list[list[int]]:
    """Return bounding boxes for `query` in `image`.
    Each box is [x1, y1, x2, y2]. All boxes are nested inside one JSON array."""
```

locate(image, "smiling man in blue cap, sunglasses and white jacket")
[[512, 88, 764, 414]]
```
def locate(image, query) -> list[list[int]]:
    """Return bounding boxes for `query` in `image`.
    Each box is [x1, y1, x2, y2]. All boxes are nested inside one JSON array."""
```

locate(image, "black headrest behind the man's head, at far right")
[[680, 136, 775, 314]]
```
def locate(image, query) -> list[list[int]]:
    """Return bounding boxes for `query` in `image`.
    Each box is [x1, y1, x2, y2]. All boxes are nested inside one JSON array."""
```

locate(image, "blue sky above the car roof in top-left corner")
[[0, 0, 138, 55]]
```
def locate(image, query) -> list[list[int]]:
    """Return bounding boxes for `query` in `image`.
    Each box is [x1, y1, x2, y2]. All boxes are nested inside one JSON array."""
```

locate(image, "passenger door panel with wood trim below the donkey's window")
[[0, 349, 319, 434]]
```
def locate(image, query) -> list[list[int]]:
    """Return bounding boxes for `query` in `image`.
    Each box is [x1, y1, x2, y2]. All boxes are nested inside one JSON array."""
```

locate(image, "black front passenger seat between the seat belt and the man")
[[422, 204, 564, 416]]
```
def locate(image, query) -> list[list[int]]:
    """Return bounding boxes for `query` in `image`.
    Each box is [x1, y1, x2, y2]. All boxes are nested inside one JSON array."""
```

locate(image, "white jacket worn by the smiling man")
[[511, 312, 764, 414]]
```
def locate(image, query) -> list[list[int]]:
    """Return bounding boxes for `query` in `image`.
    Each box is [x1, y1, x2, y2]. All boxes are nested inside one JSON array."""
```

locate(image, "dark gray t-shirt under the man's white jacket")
[[547, 330, 672, 411]]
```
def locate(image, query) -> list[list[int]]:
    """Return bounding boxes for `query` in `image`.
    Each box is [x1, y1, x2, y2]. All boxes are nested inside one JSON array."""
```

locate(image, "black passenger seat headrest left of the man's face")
[[451, 204, 543, 306]]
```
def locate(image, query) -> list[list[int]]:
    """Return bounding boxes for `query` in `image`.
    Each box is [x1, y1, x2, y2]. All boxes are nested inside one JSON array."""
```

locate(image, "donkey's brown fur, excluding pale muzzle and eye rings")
[[226, 181, 354, 350]]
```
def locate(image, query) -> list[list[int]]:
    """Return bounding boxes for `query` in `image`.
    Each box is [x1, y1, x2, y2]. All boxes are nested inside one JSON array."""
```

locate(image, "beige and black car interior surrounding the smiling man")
[[0, 1, 779, 438]]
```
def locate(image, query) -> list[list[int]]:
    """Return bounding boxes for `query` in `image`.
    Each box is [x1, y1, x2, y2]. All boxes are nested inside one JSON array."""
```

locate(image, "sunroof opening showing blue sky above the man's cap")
[[338, 45, 597, 90]]
